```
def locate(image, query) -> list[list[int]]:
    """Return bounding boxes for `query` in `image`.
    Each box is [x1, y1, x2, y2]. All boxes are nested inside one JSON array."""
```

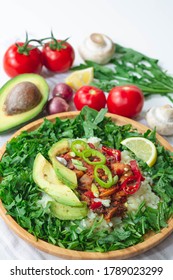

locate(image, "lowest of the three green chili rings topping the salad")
[[94, 164, 113, 189]]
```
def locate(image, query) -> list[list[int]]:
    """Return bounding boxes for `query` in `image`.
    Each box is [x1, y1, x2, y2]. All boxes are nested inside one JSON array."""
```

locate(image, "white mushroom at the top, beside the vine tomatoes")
[[79, 33, 115, 64]]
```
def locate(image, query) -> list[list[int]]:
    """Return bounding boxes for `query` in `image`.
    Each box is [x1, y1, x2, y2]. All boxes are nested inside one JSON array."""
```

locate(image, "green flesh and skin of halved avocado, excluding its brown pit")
[[0, 74, 49, 134]]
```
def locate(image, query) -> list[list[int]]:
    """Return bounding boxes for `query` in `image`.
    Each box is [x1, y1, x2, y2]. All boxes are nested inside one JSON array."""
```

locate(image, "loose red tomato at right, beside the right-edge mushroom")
[[107, 85, 144, 118]]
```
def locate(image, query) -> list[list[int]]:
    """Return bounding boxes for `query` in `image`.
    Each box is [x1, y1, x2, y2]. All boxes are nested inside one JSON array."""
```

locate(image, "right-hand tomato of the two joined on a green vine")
[[42, 40, 75, 73]]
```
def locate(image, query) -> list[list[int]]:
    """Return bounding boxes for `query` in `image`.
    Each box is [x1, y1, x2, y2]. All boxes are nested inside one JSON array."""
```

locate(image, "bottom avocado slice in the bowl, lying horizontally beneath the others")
[[50, 201, 88, 220]]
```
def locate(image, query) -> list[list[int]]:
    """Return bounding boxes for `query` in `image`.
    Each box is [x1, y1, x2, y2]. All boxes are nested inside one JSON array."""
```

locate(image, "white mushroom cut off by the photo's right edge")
[[146, 105, 173, 136]]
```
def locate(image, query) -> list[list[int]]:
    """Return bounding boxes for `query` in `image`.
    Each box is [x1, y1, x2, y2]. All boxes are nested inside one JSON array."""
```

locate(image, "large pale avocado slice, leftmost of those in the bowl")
[[33, 153, 82, 207]]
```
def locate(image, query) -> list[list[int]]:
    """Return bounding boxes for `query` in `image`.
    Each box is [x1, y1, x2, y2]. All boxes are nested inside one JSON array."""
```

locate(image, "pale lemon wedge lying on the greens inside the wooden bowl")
[[121, 137, 157, 167]]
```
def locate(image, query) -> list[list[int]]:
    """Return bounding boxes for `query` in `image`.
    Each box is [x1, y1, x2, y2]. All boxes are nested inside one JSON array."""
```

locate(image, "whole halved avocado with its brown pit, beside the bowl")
[[0, 74, 49, 133]]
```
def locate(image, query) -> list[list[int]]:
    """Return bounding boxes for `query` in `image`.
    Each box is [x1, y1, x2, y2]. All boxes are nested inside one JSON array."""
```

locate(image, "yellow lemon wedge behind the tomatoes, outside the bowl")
[[65, 67, 94, 90]]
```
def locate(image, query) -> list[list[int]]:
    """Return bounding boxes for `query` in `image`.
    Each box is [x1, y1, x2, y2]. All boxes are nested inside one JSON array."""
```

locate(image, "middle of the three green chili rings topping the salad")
[[82, 149, 106, 165]]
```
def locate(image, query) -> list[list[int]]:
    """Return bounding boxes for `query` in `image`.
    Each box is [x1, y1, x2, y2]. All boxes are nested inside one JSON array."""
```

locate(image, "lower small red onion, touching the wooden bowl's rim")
[[47, 96, 69, 115]]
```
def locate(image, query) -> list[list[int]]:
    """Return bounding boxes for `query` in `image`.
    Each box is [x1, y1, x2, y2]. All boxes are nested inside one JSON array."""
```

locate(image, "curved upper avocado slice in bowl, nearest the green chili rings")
[[48, 139, 77, 189]]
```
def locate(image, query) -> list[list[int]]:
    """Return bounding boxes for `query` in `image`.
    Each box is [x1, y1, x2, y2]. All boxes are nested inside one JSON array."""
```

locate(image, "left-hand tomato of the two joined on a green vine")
[[3, 42, 42, 77]]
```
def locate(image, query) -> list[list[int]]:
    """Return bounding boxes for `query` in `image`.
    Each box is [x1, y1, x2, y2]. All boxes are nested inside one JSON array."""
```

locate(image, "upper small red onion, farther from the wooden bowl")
[[52, 83, 73, 102]]
